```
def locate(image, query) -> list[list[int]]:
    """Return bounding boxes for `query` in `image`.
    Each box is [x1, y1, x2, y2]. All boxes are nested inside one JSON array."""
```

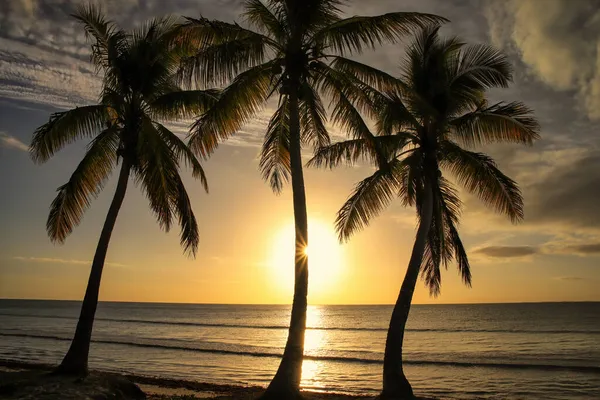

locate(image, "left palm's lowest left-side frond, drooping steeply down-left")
[[46, 127, 119, 243]]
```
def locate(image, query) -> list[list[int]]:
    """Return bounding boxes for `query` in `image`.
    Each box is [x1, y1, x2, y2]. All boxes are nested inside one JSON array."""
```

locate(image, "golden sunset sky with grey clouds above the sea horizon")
[[0, 0, 600, 304]]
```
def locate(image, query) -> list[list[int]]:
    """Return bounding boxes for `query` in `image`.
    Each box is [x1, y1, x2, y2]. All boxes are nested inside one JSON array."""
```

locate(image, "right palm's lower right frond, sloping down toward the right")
[[440, 141, 523, 222]]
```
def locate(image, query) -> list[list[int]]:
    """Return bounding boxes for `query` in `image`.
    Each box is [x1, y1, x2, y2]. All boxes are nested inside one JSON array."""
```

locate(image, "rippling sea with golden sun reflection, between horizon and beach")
[[0, 300, 600, 400]]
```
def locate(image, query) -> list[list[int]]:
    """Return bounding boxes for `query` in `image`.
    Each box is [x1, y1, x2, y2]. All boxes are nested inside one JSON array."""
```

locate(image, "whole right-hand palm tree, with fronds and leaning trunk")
[[309, 27, 539, 399]]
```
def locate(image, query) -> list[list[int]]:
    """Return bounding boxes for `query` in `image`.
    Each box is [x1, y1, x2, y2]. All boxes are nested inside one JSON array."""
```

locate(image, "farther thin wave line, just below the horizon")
[[0, 313, 600, 335]]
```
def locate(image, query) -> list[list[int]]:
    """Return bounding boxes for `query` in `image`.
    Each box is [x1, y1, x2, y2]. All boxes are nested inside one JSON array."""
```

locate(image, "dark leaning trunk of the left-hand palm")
[[55, 158, 131, 375]]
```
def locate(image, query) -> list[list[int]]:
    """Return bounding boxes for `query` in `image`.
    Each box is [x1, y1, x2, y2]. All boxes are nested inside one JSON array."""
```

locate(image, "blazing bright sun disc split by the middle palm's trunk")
[[269, 219, 343, 294]]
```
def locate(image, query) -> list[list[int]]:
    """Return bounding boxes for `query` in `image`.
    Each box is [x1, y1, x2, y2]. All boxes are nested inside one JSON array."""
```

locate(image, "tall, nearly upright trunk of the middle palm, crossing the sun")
[[263, 76, 308, 400]]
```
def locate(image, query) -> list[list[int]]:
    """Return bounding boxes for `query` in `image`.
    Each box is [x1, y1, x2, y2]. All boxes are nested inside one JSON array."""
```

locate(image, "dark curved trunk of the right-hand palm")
[[380, 186, 433, 400]]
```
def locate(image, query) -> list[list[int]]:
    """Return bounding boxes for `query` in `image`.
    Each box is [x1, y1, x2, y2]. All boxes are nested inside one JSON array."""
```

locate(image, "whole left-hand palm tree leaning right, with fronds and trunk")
[[30, 6, 216, 374]]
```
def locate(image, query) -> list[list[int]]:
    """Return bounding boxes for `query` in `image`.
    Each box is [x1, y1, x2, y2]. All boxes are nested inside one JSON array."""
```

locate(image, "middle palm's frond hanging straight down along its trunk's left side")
[[259, 96, 291, 194]]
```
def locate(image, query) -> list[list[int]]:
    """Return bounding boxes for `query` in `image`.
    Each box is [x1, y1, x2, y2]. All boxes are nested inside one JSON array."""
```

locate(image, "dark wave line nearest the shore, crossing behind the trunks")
[[0, 333, 600, 374]]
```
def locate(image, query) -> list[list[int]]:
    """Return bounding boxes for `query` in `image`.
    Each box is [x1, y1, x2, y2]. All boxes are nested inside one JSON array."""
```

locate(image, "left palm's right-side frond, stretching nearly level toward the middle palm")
[[149, 89, 219, 120]]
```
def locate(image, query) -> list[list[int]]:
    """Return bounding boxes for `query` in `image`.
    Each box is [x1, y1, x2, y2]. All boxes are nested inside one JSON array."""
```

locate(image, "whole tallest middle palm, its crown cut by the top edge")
[[176, 0, 445, 399]]
